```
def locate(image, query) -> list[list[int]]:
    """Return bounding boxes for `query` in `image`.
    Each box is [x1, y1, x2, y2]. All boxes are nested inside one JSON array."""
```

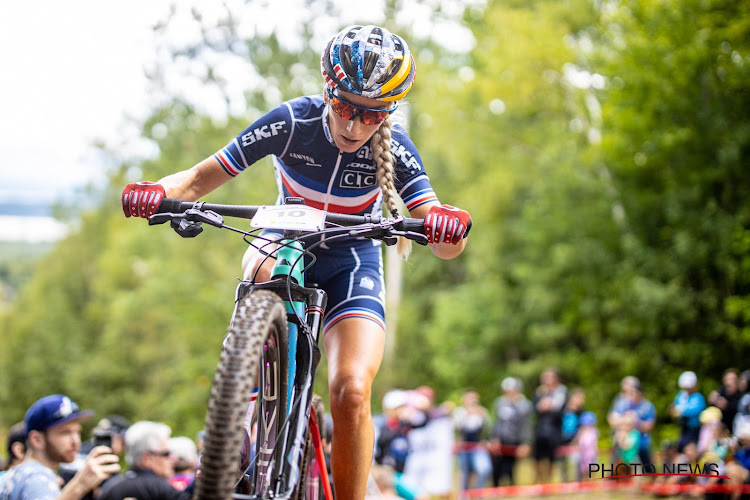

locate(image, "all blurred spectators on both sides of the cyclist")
[[5, 368, 750, 500]]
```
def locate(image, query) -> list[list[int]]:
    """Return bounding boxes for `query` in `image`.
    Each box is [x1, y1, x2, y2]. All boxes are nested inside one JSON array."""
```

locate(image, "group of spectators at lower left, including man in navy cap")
[[0, 394, 202, 500]]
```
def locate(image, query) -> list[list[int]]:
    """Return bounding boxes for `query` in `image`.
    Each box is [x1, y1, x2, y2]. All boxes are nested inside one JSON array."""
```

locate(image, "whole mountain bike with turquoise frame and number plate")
[[149, 198, 427, 500]]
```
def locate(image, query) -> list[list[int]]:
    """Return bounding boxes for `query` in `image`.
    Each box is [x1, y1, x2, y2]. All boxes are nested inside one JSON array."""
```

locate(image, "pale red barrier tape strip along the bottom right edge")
[[459, 479, 750, 498]]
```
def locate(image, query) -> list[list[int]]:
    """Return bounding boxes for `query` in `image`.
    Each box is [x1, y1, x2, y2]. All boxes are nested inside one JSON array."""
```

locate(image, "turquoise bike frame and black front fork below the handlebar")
[[234, 232, 333, 500]]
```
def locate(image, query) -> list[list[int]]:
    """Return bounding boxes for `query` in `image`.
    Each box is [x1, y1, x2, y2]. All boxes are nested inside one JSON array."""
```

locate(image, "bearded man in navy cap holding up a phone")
[[0, 394, 120, 500]]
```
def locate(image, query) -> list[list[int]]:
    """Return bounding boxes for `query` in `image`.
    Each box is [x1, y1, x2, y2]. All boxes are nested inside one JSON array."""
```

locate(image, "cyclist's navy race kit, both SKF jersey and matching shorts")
[[220, 95, 437, 332]]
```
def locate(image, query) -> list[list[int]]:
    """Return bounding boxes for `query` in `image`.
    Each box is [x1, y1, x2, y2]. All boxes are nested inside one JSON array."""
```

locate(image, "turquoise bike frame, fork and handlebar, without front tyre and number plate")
[[149, 198, 427, 500]]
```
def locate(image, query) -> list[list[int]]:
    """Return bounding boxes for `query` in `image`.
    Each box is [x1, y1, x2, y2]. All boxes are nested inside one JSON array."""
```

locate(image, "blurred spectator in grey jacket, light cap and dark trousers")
[[490, 377, 534, 486]]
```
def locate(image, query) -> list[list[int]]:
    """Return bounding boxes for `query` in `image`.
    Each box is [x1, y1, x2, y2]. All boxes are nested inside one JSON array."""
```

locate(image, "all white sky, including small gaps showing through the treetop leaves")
[[0, 0, 476, 241]]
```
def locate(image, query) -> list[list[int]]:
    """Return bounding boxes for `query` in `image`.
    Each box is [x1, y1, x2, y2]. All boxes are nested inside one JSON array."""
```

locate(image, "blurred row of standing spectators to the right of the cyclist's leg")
[[375, 368, 750, 499]]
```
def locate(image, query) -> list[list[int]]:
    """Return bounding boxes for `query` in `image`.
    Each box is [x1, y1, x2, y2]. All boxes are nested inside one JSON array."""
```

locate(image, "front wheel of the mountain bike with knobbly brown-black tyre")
[[193, 290, 288, 500]]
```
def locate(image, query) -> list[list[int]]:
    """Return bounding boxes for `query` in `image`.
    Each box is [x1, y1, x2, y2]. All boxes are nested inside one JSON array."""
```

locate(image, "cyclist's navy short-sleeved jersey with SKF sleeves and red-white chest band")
[[215, 95, 437, 223]]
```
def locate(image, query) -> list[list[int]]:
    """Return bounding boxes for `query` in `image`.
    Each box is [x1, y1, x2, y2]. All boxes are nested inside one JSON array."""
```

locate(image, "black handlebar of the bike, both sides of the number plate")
[[149, 198, 427, 245]]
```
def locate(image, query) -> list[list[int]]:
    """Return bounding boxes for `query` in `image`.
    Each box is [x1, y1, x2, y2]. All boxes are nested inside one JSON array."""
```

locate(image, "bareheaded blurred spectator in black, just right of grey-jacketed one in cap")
[[534, 368, 567, 483]]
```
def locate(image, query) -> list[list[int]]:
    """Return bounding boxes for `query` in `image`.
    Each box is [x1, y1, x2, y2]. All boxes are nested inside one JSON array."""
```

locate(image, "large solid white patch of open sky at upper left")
[[0, 0, 173, 207]]
